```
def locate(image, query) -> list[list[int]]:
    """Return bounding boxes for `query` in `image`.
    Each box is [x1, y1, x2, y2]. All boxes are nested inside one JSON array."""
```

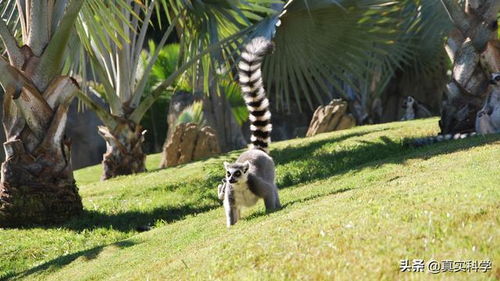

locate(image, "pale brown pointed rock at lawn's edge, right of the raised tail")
[[306, 99, 356, 137]]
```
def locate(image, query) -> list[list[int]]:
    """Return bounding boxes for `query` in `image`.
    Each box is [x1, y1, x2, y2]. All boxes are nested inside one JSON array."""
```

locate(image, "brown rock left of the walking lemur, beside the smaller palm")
[[161, 123, 220, 168]]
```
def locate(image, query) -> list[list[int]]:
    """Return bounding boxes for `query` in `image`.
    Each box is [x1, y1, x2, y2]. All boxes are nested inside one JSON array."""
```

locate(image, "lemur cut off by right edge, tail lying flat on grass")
[[410, 72, 500, 147]]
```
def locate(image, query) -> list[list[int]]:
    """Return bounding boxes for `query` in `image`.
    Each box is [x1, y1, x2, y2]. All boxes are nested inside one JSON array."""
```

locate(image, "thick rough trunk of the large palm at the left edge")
[[0, 74, 83, 227]]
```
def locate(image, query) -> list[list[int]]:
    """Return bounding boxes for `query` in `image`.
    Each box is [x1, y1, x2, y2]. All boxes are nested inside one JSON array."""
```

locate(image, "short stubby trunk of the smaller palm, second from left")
[[99, 117, 146, 180]]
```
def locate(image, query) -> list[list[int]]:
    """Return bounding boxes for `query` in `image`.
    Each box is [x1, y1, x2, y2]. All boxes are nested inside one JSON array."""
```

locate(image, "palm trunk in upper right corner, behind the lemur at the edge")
[[439, 0, 500, 134]]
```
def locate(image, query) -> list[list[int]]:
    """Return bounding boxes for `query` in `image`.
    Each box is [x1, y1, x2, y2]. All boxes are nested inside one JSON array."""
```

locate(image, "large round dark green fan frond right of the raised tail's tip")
[[264, 0, 398, 110]]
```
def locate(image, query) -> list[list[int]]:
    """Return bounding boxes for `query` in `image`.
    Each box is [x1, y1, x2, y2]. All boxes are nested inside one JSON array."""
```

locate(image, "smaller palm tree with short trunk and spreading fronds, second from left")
[[79, 0, 274, 179]]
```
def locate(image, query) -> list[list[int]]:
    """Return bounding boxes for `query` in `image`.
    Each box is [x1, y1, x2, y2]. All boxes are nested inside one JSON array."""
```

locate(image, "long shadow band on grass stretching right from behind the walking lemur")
[[272, 133, 500, 189]]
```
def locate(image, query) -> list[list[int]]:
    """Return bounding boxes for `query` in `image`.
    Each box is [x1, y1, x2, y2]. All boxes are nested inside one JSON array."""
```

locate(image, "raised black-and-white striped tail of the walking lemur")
[[238, 37, 273, 152]]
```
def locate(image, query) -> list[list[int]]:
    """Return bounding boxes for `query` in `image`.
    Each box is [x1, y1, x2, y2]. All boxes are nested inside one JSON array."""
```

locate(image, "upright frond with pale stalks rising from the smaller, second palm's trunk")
[[76, 0, 154, 117]]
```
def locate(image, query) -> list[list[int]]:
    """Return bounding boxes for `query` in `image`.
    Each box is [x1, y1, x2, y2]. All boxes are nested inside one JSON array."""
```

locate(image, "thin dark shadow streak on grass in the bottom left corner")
[[9, 240, 139, 280]]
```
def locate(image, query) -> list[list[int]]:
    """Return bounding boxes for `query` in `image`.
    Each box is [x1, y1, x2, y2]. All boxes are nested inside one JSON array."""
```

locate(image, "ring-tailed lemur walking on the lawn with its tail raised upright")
[[218, 37, 281, 227]]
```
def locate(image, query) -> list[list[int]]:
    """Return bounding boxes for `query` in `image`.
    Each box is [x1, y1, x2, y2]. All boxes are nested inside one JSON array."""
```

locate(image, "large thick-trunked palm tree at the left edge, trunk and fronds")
[[0, 0, 134, 226]]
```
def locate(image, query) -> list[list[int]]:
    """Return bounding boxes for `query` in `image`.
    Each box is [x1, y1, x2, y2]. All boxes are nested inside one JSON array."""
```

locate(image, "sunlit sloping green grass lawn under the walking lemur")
[[0, 119, 500, 280]]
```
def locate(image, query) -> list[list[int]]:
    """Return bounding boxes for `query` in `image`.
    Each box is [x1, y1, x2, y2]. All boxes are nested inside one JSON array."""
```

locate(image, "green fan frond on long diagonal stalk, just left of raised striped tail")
[[130, 0, 273, 121]]
